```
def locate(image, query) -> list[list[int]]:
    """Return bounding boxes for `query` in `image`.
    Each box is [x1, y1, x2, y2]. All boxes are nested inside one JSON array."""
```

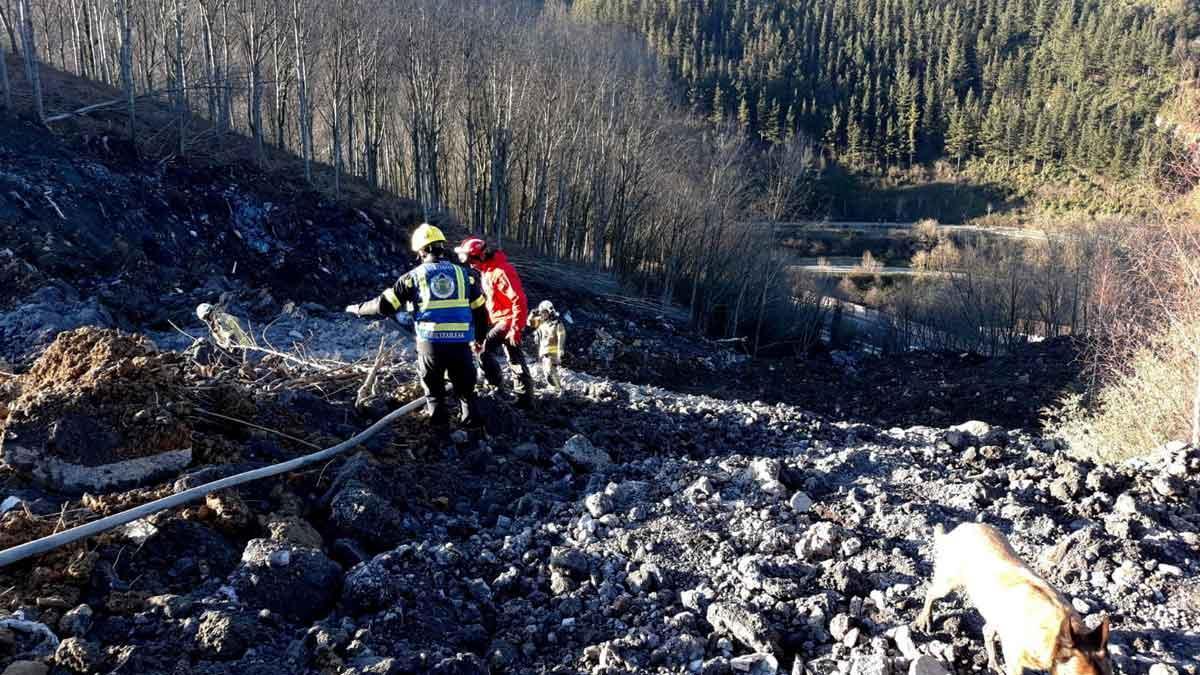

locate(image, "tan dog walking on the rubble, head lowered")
[[916, 522, 1112, 675]]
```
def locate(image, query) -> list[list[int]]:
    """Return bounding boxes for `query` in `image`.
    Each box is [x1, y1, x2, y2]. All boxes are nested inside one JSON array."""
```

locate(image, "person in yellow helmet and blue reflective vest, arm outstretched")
[[346, 223, 487, 442]]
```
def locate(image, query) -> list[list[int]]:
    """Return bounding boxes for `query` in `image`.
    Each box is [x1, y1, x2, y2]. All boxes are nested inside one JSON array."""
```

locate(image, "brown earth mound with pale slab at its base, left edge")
[[0, 327, 192, 494]]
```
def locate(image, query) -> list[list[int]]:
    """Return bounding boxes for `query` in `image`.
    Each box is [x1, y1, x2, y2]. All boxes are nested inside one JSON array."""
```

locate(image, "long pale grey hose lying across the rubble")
[[0, 396, 426, 567]]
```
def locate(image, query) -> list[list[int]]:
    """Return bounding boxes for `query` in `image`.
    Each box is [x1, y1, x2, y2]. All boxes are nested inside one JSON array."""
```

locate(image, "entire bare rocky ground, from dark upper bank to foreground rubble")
[[0, 110, 1200, 675]]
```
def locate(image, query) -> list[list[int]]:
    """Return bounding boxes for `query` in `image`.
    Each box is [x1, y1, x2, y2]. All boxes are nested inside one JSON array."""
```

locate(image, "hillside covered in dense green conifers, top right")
[[575, 0, 1200, 177]]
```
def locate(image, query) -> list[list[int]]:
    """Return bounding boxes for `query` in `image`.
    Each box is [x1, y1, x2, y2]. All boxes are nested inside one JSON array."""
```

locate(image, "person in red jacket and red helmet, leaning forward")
[[455, 237, 533, 407]]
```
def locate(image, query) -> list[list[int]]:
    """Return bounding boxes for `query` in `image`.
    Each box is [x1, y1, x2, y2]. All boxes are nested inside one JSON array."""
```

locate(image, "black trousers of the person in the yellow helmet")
[[416, 340, 482, 432]]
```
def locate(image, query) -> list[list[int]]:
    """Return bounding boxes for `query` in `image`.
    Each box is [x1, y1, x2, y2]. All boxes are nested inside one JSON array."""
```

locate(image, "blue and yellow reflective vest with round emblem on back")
[[393, 262, 475, 342]]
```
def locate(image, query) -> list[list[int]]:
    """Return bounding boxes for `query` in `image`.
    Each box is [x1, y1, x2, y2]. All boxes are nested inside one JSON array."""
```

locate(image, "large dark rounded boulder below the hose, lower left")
[[230, 539, 342, 620]]
